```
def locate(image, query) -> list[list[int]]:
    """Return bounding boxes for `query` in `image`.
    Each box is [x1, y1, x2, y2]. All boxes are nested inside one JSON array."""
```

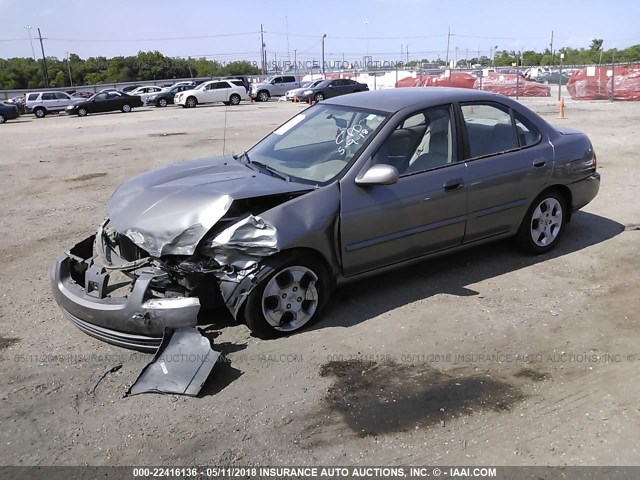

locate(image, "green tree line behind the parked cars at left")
[[0, 51, 260, 90]]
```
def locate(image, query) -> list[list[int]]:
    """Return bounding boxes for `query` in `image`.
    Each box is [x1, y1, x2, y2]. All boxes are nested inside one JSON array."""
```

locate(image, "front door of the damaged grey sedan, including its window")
[[340, 105, 467, 276]]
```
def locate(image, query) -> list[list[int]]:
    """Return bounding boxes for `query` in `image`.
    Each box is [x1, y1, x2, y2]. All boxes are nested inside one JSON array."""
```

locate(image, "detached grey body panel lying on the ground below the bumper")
[[125, 327, 220, 396]]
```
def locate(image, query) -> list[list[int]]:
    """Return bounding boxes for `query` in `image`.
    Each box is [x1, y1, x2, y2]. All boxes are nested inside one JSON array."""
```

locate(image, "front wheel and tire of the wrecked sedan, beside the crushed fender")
[[244, 257, 330, 339]]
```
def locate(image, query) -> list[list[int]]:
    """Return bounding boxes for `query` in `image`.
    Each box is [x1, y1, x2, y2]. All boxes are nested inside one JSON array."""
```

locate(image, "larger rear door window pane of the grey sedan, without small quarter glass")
[[462, 104, 518, 158]]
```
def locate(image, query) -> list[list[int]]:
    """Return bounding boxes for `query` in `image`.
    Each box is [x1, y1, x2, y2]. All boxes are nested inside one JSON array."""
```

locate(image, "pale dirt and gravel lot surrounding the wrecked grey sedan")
[[0, 95, 640, 465]]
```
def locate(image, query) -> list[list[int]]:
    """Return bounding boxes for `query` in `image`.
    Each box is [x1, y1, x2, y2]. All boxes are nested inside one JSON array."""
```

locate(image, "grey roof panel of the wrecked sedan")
[[322, 87, 508, 113]]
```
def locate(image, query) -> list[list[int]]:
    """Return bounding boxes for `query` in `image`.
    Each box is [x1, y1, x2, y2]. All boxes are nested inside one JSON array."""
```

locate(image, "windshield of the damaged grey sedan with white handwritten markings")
[[248, 104, 386, 184]]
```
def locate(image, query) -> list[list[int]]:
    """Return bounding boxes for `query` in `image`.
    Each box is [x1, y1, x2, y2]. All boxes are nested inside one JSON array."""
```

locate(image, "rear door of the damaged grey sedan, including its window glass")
[[460, 102, 553, 242]]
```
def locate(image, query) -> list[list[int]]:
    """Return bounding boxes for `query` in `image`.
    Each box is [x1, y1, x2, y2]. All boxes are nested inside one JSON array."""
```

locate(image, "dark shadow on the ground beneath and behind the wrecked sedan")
[[309, 212, 624, 330]]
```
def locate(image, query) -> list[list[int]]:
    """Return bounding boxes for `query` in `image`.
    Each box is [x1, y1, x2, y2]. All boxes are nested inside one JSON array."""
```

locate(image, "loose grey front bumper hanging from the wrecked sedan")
[[51, 236, 200, 352]]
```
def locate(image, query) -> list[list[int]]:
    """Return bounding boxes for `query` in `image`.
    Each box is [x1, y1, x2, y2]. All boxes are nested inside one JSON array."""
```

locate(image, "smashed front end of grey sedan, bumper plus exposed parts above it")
[[51, 222, 200, 351]]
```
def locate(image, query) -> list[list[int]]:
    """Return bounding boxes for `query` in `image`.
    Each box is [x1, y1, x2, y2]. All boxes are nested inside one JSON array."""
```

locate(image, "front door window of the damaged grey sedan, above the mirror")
[[372, 106, 457, 177]]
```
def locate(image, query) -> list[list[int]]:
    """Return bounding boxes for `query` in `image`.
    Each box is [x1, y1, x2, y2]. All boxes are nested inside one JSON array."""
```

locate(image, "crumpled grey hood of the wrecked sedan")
[[107, 156, 311, 257]]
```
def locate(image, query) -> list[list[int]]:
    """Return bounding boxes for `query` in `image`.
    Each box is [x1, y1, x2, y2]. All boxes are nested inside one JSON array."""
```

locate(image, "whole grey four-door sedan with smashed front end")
[[51, 88, 600, 351]]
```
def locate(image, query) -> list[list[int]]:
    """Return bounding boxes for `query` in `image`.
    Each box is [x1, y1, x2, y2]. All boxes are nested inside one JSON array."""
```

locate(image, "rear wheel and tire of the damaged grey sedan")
[[516, 190, 568, 255]]
